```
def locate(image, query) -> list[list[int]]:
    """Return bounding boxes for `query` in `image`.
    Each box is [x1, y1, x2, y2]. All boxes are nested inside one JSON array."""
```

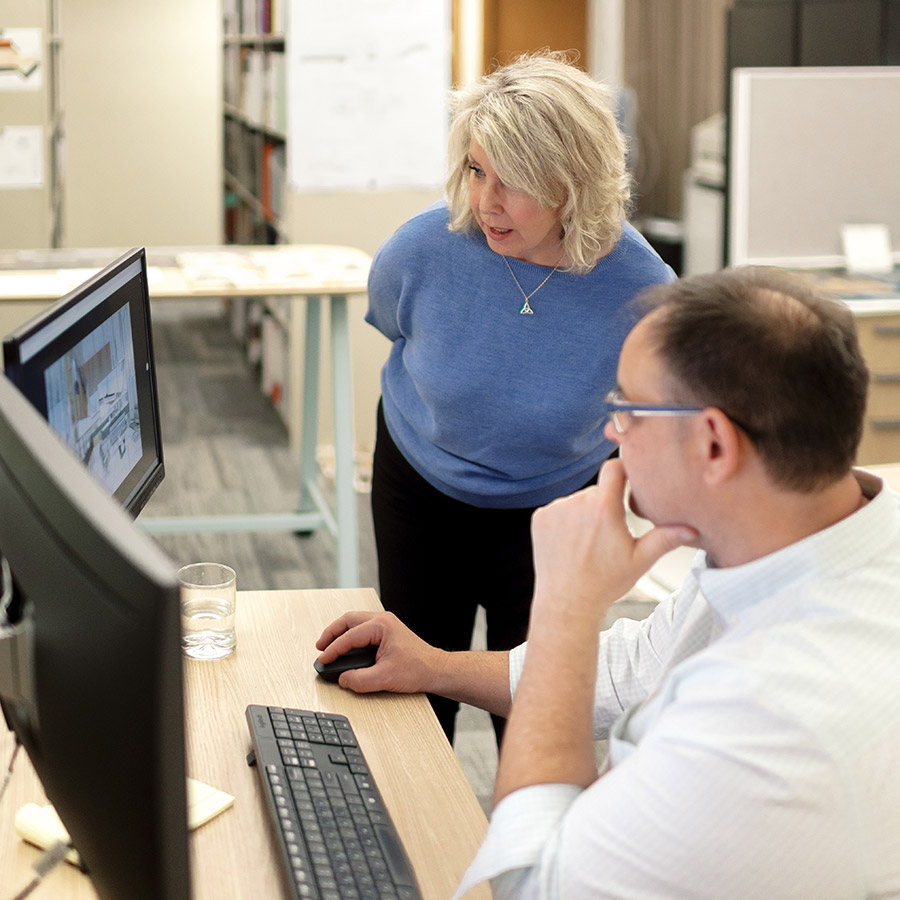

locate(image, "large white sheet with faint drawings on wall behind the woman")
[[286, 0, 451, 192]]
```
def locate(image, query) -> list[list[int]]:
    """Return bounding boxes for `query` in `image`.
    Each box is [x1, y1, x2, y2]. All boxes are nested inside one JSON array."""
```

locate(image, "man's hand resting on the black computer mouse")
[[316, 612, 446, 694]]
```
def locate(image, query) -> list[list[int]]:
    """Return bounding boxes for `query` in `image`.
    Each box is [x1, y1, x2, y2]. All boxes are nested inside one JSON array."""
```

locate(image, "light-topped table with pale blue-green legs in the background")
[[0, 245, 371, 587]]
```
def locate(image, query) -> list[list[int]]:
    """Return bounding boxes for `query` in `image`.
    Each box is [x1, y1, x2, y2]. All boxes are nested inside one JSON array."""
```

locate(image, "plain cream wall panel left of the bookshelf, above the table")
[[62, 0, 222, 247]]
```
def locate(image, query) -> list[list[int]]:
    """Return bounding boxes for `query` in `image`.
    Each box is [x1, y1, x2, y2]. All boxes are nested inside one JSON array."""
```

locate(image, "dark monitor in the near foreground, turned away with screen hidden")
[[0, 375, 190, 900]]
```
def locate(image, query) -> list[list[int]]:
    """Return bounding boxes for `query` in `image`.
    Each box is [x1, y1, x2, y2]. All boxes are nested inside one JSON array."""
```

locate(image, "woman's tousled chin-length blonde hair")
[[447, 51, 631, 272]]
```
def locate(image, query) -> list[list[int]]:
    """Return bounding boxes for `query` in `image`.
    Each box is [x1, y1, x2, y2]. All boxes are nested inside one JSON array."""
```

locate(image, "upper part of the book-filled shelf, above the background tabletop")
[[222, 0, 287, 244]]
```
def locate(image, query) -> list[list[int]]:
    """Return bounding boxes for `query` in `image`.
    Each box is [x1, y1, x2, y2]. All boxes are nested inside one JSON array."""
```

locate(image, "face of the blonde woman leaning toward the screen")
[[469, 141, 563, 266]]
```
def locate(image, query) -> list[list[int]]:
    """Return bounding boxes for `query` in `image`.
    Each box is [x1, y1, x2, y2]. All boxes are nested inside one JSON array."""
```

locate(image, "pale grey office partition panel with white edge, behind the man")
[[728, 66, 900, 267]]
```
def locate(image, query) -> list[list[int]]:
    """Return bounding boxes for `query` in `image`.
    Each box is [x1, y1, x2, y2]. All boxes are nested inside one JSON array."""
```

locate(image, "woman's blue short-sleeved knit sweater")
[[366, 202, 674, 508]]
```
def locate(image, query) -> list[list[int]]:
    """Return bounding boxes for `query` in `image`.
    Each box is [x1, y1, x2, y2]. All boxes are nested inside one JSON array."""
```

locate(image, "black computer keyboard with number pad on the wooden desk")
[[247, 706, 421, 900]]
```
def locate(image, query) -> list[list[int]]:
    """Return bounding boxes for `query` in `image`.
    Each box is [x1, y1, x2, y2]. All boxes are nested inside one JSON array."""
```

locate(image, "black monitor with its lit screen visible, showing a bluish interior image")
[[3, 249, 165, 516]]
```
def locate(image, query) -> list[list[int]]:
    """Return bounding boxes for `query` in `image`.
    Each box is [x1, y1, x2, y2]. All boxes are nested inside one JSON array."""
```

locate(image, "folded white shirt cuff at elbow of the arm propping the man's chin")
[[453, 784, 583, 900]]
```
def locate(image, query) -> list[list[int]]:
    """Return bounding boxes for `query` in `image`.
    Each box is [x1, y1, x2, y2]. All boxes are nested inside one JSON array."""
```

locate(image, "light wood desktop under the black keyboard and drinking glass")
[[0, 589, 490, 900]]
